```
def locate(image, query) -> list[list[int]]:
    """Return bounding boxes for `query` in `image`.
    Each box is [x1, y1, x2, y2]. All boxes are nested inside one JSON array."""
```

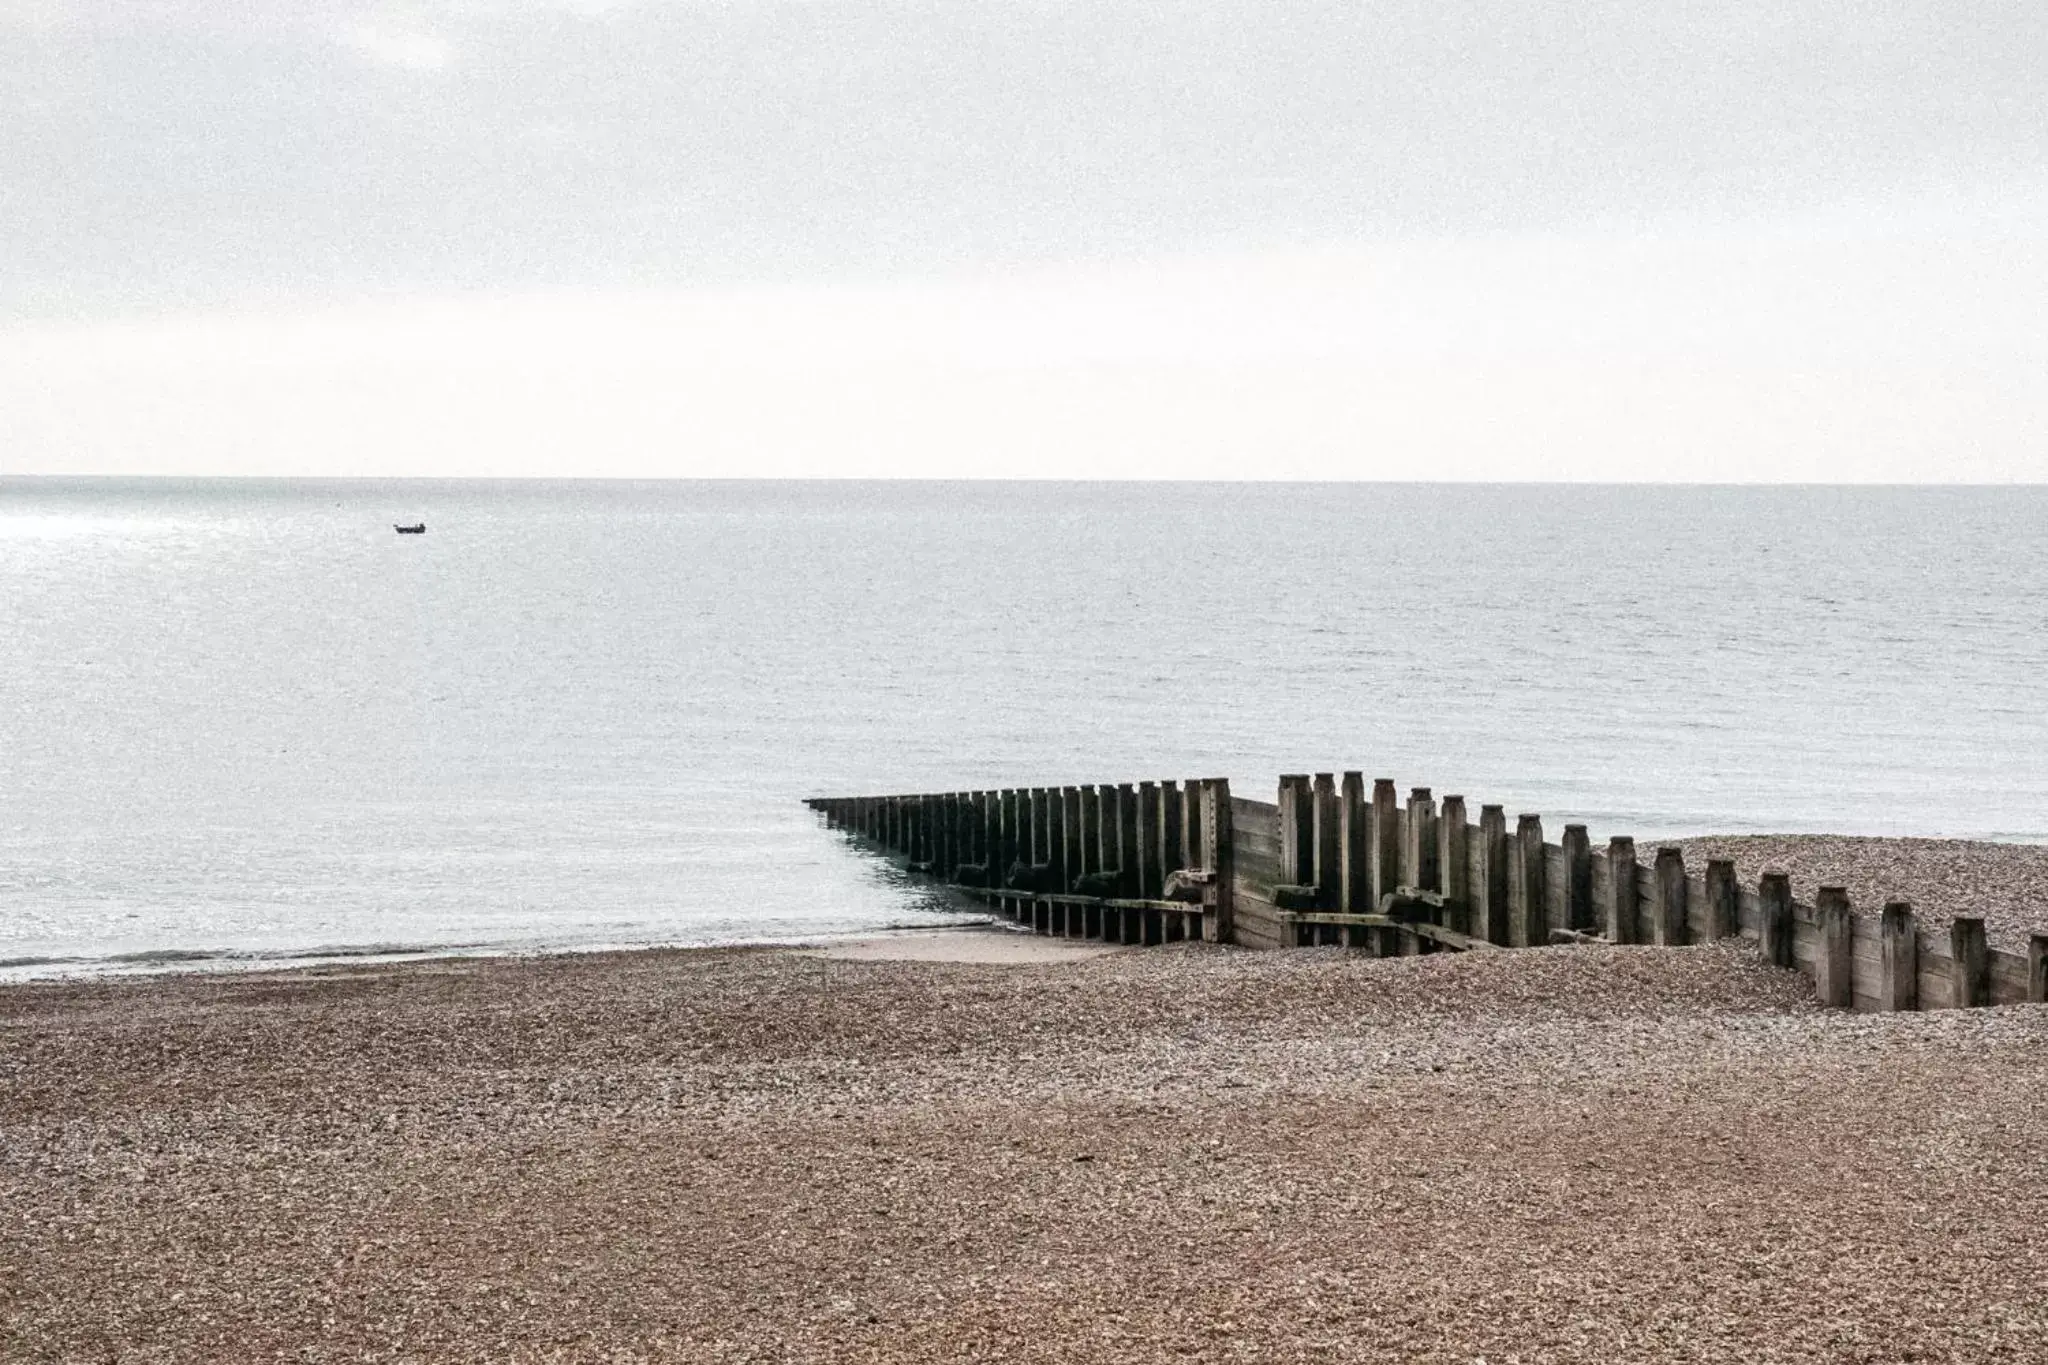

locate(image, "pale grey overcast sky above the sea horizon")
[[0, 0, 2048, 481]]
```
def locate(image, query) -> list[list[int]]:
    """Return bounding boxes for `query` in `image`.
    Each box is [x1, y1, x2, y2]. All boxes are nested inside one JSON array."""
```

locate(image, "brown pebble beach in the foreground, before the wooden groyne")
[[0, 929, 2048, 1365]]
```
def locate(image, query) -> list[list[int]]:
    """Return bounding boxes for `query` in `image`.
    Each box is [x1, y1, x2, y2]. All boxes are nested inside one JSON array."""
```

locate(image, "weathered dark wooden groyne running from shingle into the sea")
[[807, 772, 2048, 1011]]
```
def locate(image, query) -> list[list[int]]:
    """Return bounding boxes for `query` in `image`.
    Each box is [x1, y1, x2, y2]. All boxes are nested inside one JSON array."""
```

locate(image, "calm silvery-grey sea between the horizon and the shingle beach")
[[0, 479, 2048, 974]]
